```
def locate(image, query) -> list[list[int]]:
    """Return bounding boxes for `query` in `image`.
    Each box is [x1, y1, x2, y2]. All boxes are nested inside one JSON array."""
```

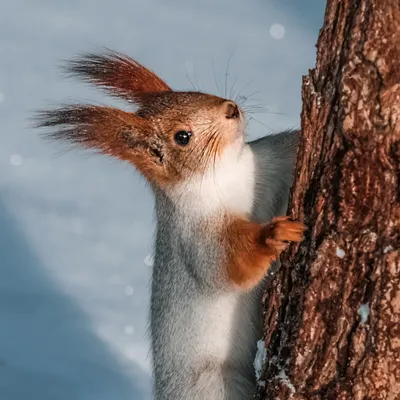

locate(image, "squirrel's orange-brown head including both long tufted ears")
[[37, 52, 245, 189]]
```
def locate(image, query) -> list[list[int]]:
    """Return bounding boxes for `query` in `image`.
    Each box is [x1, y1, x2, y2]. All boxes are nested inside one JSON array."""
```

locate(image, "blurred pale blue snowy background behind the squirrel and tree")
[[0, 0, 325, 400]]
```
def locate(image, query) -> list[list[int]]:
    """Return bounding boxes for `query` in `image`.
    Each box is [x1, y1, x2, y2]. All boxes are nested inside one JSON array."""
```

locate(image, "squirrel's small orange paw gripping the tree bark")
[[262, 216, 306, 256]]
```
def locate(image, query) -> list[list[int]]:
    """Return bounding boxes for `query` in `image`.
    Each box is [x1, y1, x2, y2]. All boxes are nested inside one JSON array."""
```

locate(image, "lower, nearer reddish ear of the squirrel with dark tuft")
[[35, 104, 169, 182]]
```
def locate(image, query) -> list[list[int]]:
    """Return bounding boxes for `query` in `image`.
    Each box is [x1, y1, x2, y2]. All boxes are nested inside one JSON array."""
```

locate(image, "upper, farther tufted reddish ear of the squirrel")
[[65, 51, 171, 103]]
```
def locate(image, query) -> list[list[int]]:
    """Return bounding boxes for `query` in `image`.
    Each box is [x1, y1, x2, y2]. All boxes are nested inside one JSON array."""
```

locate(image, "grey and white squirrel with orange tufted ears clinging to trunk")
[[36, 51, 305, 400]]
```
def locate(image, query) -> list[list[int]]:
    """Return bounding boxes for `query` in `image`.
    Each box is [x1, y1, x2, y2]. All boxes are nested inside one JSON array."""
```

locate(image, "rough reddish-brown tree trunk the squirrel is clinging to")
[[256, 0, 400, 400]]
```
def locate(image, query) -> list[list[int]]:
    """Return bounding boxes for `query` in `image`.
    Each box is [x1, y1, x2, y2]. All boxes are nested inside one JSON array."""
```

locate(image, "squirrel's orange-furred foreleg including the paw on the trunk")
[[222, 217, 305, 290]]
